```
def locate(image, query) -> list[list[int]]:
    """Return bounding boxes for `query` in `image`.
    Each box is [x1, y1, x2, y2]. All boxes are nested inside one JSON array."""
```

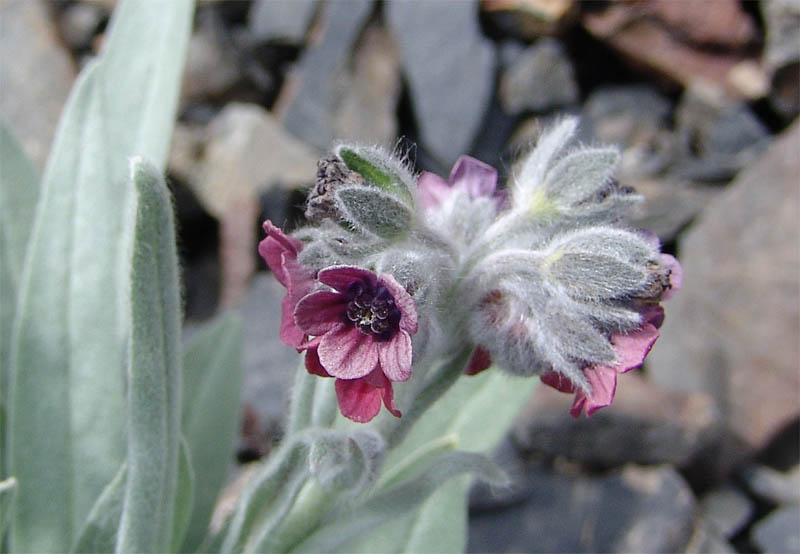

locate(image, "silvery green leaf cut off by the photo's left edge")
[[0, 119, 39, 479]]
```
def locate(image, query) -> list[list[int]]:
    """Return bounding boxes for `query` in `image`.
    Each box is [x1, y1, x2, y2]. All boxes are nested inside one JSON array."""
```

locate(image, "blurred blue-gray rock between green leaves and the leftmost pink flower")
[[240, 273, 301, 428]]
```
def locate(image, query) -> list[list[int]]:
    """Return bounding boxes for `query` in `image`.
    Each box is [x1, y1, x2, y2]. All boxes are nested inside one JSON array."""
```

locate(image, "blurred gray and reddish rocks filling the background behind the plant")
[[0, 0, 800, 552]]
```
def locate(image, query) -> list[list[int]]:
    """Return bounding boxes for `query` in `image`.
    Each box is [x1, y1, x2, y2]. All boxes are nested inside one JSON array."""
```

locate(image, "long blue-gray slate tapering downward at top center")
[[385, 0, 496, 167]]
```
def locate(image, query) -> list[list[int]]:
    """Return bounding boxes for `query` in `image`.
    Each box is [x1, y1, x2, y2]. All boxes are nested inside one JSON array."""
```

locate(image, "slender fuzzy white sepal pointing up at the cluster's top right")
[[512, 117, 578, 205]]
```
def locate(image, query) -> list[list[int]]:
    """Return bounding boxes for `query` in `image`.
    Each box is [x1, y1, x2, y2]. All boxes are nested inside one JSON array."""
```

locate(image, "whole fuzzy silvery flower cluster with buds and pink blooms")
[[259, 119, 682, 422]]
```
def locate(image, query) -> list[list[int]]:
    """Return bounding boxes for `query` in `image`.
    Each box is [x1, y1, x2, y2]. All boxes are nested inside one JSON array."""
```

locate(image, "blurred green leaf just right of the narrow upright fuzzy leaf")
[[181, 314, 242, 552]]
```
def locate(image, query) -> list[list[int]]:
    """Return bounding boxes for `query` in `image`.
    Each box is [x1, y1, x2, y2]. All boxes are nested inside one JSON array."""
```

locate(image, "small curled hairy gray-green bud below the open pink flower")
[[308, 429, 386, 496]]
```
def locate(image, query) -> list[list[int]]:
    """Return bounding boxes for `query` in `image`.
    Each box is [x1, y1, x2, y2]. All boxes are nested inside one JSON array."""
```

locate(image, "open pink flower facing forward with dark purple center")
[[294, 266, 417, 422]]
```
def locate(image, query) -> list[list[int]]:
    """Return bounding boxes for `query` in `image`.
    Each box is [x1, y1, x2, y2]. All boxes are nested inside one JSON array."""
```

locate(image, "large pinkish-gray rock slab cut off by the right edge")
[[647, 123, 800, 465]]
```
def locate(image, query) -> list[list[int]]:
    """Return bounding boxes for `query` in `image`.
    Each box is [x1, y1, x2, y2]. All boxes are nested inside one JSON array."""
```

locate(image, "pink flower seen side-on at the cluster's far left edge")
[[258, 220, 314, 348]]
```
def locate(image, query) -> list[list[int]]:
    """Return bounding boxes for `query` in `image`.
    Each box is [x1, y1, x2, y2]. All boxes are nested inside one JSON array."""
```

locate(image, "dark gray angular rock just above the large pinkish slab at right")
[[672, 82, 771, 181]]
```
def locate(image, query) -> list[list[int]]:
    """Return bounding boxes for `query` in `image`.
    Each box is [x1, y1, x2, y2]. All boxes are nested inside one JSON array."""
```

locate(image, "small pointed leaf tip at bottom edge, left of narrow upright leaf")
[[71, 463, 128, 552]]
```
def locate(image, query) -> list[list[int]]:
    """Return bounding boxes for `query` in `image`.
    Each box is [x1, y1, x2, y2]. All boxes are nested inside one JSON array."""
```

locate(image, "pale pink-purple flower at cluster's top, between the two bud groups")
[[417, 156, 503, 211]]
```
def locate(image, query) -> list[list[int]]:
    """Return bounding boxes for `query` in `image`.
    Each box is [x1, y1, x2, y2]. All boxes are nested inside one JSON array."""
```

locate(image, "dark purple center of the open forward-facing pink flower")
[[345, 281, 401, 340]]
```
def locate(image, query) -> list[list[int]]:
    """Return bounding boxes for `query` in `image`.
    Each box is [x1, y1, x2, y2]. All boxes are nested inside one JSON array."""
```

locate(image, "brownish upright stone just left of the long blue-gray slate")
[[333, 24, 401, 149]]
